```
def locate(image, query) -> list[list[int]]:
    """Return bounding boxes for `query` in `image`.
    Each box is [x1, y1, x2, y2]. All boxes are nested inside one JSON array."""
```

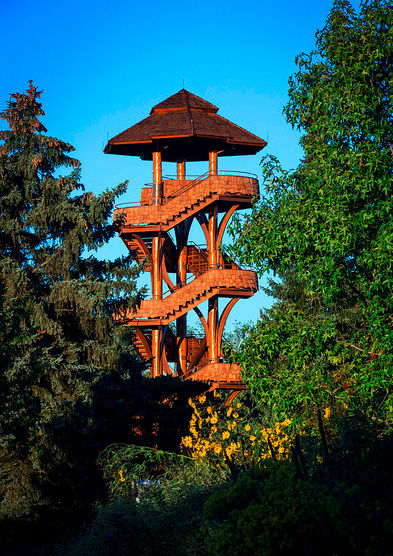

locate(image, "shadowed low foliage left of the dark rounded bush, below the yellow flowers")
[[56, 454, 223, 556]]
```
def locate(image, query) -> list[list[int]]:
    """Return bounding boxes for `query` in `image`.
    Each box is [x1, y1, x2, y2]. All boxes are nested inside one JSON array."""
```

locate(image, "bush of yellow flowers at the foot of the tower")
[[181, 395, 294, 469]]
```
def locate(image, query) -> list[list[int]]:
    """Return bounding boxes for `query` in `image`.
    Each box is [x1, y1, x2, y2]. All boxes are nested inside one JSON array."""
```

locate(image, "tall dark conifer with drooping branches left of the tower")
[[0, 82, 141, 528]]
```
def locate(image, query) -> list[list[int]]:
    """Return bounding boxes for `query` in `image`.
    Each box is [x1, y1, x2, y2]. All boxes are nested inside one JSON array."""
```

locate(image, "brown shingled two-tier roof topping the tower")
[[104, 89, 267, 162]]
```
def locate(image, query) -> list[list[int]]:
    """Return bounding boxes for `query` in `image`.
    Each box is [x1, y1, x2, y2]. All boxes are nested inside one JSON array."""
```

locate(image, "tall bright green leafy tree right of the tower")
[[225, 0, 393, 422]]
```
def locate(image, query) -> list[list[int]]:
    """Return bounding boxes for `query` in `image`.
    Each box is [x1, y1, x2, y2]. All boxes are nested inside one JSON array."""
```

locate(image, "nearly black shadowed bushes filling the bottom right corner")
[[205, 418, 393, 556]]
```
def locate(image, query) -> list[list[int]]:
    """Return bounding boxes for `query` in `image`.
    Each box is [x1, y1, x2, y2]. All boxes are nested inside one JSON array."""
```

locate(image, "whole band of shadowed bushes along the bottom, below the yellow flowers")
[[52, 408, 393, 556]]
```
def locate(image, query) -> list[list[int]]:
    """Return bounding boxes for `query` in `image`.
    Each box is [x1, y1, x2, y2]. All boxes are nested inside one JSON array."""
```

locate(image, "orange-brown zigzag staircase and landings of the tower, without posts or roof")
[[114, 169, 258, 389]]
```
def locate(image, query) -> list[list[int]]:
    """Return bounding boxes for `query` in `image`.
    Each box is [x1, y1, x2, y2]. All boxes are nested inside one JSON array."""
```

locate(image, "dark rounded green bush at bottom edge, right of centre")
[[205, 462, 336, 556]]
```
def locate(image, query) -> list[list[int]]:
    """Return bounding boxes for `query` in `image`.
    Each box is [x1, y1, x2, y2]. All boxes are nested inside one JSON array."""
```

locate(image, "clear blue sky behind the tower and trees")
[[0, 0, 358, 330]]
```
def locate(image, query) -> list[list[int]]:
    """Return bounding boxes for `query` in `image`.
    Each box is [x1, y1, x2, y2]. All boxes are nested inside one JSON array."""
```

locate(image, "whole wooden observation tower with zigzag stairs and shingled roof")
[[104, 89, 266, 390]]
